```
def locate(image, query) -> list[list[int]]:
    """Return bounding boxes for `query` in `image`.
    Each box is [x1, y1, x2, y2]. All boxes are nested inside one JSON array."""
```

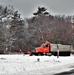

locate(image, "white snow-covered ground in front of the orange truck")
[[0, 55, 74, 75]]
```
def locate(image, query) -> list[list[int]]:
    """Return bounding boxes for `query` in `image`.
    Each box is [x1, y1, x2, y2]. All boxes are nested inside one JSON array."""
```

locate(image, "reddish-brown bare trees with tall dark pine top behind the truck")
[[28, 7, 74, 49]]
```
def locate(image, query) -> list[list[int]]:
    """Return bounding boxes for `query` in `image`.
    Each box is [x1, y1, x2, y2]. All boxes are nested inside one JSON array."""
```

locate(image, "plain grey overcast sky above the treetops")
[[0, 0, 74, 17]]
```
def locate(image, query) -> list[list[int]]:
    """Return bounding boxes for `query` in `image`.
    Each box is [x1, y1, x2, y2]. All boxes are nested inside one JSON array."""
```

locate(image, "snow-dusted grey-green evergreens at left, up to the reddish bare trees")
[[0, 6, 25, 53]]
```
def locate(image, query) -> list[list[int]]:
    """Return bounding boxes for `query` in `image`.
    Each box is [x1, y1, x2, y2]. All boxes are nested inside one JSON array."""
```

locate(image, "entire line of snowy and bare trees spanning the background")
[[0, 5, 74, 53]]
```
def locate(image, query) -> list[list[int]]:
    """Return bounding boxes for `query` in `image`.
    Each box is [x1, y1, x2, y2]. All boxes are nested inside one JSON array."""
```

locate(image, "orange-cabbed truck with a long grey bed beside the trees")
[[27, 41, 71, 56]]
